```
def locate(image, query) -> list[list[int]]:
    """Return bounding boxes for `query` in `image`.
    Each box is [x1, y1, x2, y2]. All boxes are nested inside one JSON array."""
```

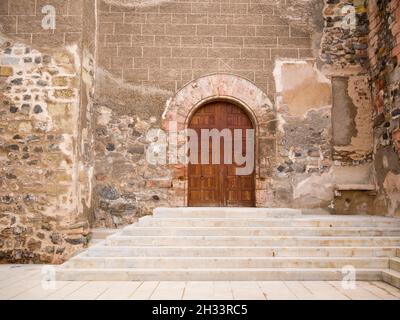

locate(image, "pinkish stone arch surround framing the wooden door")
[[162, 73, 276, 207]]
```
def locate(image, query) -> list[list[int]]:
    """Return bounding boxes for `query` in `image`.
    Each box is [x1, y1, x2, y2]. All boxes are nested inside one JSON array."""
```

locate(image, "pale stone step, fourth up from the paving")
[[105, 234, 400, 247]]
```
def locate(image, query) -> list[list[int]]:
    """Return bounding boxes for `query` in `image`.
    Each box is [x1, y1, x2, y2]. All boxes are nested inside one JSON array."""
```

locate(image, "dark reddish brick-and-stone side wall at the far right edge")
[[369, 0, 400, 215]]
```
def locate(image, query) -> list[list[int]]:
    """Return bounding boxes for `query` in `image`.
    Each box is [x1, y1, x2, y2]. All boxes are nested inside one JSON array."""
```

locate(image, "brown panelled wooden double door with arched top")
[[188, 101, 255, 207]]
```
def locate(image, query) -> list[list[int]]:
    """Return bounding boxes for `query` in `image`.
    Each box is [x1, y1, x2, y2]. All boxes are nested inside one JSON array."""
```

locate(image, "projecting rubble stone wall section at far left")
[[0, 0, 89, 263]]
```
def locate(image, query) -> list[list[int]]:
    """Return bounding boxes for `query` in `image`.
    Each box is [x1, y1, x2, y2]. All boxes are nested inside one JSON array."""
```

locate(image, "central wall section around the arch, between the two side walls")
[[91, 0, 382, 226]]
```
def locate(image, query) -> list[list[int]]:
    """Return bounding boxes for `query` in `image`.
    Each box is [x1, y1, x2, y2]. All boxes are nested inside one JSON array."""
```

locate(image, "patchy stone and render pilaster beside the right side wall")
[[314, 0, 376, 214]]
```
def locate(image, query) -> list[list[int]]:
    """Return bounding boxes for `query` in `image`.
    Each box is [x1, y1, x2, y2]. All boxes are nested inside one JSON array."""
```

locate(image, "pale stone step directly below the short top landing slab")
[[135, 216, 400, 228]]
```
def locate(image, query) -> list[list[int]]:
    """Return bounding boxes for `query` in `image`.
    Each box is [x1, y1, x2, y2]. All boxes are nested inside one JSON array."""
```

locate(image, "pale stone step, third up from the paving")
[[85, 246, 396, 257]]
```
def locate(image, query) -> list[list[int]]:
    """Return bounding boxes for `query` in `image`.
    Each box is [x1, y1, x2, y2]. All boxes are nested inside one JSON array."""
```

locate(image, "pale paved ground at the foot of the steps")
[[0, 265, 400, 300]]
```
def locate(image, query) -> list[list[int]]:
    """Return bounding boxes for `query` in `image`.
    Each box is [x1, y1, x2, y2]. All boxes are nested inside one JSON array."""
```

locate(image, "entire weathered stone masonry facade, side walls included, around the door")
[[0, 0, 400, 263]]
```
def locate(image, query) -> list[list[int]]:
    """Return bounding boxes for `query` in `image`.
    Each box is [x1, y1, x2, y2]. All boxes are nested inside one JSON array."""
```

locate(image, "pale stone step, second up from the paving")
[[65, 257, 389, 269]]
